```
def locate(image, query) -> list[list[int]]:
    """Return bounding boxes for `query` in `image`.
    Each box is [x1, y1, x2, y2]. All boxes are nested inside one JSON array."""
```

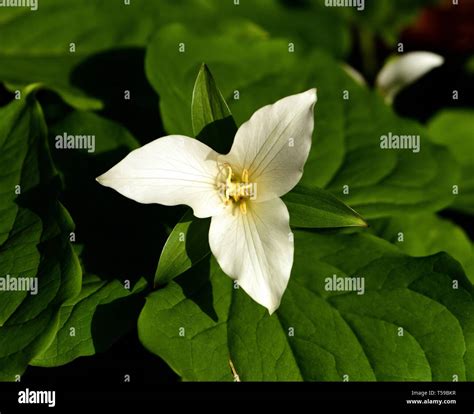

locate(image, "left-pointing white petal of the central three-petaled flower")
[[97, 135, 223, 218]]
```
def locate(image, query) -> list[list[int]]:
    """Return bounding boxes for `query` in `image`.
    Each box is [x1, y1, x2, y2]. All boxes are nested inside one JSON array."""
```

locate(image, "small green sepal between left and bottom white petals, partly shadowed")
[[155, 210, 211, 285]]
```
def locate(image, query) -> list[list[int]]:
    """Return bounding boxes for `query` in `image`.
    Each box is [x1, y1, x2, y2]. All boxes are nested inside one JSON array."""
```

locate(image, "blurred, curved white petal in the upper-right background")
[[375, 52, 444, 103]]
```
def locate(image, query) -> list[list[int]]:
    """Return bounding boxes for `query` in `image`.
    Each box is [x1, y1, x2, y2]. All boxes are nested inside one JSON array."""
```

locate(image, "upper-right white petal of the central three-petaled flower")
[[222, 89, 316, 202]]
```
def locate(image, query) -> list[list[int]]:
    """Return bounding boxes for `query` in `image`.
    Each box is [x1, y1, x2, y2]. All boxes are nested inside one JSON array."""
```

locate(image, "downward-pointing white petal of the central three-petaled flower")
[[209, 198, 294, 314]]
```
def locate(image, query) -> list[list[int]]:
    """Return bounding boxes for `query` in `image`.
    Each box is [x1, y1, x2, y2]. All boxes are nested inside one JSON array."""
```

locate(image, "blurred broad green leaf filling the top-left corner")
[[0, 0, 211, 109]]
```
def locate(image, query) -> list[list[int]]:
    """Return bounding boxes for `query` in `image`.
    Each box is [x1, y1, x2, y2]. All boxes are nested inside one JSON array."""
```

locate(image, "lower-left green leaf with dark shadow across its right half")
[[31, 275, 146, 367]]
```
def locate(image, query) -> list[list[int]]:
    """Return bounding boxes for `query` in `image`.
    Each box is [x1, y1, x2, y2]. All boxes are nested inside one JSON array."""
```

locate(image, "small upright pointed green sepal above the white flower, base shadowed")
[[191, 64, 237, 154]]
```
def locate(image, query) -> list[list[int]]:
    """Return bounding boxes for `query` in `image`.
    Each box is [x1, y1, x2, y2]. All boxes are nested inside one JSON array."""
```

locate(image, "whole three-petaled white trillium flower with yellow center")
[[97, 89, 316, 314]]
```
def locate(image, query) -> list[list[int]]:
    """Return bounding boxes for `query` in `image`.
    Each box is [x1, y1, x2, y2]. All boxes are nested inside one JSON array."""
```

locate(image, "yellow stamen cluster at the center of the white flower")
[[217, 163, 256, 214]]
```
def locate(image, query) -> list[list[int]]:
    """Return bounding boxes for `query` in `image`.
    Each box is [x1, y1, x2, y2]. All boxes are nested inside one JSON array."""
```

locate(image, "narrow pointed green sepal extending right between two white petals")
[[283, 186, 367, 228]]
